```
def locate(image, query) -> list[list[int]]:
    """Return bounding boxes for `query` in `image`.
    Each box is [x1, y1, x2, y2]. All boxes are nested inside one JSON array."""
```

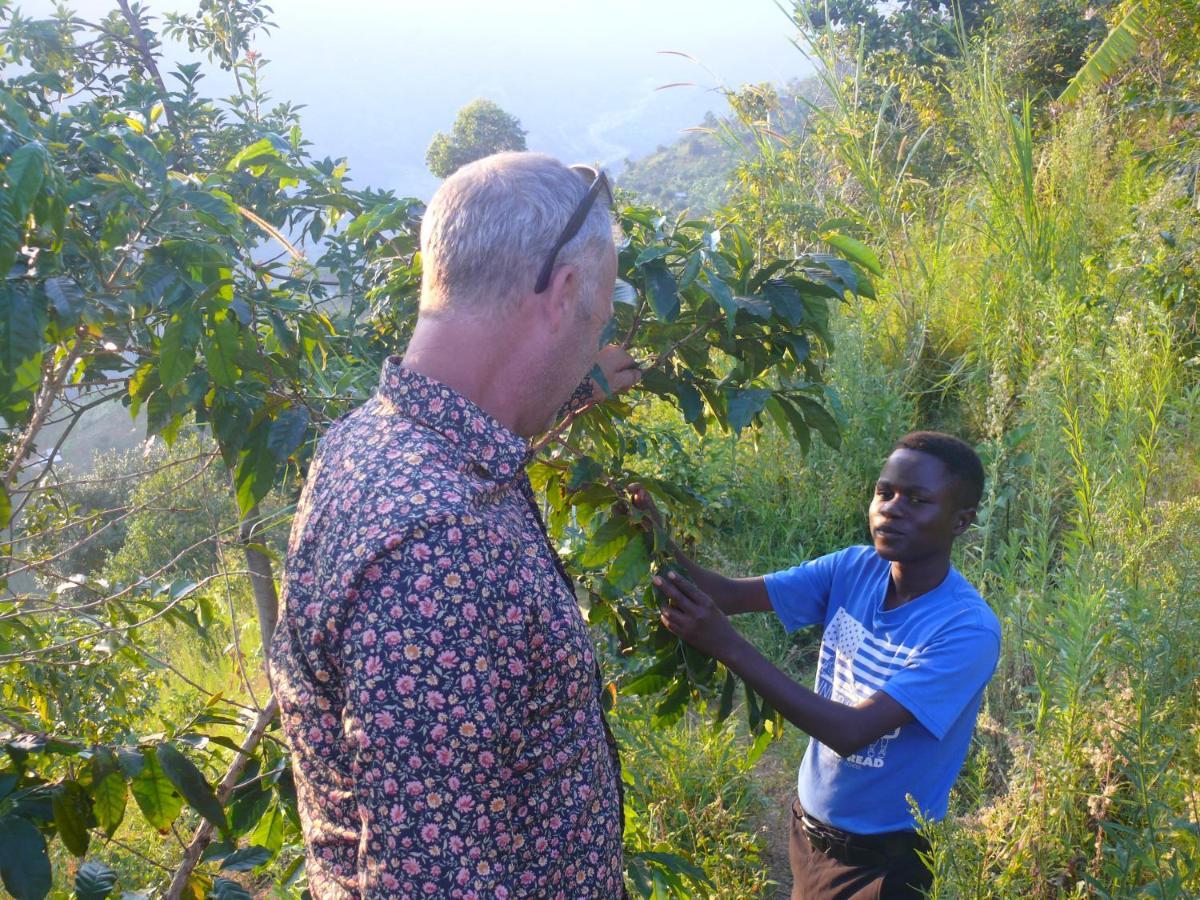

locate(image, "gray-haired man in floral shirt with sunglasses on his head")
[[271, 154, 640, 900]]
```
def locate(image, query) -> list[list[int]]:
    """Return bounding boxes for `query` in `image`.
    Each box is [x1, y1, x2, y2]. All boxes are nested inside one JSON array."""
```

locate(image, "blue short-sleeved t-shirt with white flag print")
[[766, 547, 1000, 834]]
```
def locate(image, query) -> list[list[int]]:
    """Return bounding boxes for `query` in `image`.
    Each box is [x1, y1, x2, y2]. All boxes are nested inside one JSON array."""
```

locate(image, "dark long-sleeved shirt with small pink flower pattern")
[[271, 358, 623, 900]]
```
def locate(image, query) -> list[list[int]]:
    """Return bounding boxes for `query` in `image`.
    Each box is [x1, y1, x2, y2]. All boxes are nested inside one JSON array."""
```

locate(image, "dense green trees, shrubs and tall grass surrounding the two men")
[[0, 0, 1200, 898]]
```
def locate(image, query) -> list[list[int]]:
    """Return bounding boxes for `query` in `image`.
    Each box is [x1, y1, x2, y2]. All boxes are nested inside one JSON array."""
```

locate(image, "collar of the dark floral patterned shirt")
[[377, 356, 529, 481]]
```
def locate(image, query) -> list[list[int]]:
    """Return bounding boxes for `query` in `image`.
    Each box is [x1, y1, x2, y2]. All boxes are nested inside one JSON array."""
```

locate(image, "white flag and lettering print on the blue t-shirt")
[[817, 607, 916, 769]]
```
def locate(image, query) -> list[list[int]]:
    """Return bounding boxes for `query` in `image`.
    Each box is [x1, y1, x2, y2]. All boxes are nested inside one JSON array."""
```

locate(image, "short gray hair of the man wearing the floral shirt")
[[421, 152, 613, 316]]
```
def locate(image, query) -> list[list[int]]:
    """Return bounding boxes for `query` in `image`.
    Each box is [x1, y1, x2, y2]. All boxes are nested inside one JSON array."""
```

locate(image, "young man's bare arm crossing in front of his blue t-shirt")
[[654, 572, 913, 756]]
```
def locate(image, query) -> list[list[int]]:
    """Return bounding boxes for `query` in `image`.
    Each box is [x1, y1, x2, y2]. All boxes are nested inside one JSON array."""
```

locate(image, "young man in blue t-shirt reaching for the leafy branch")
[[634, 432, 1000, 900]]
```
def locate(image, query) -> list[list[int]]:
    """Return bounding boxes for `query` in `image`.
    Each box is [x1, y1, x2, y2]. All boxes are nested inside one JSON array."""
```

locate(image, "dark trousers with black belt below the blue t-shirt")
[[788, 803, 934, 900]]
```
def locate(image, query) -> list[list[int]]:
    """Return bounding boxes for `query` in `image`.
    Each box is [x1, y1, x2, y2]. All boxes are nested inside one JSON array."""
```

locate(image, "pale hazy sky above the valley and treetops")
[[30, 0, 808, 197]]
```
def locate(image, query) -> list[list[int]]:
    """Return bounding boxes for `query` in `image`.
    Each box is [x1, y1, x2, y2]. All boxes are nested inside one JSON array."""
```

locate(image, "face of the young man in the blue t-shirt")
[[869, 449, 974, 563]]
